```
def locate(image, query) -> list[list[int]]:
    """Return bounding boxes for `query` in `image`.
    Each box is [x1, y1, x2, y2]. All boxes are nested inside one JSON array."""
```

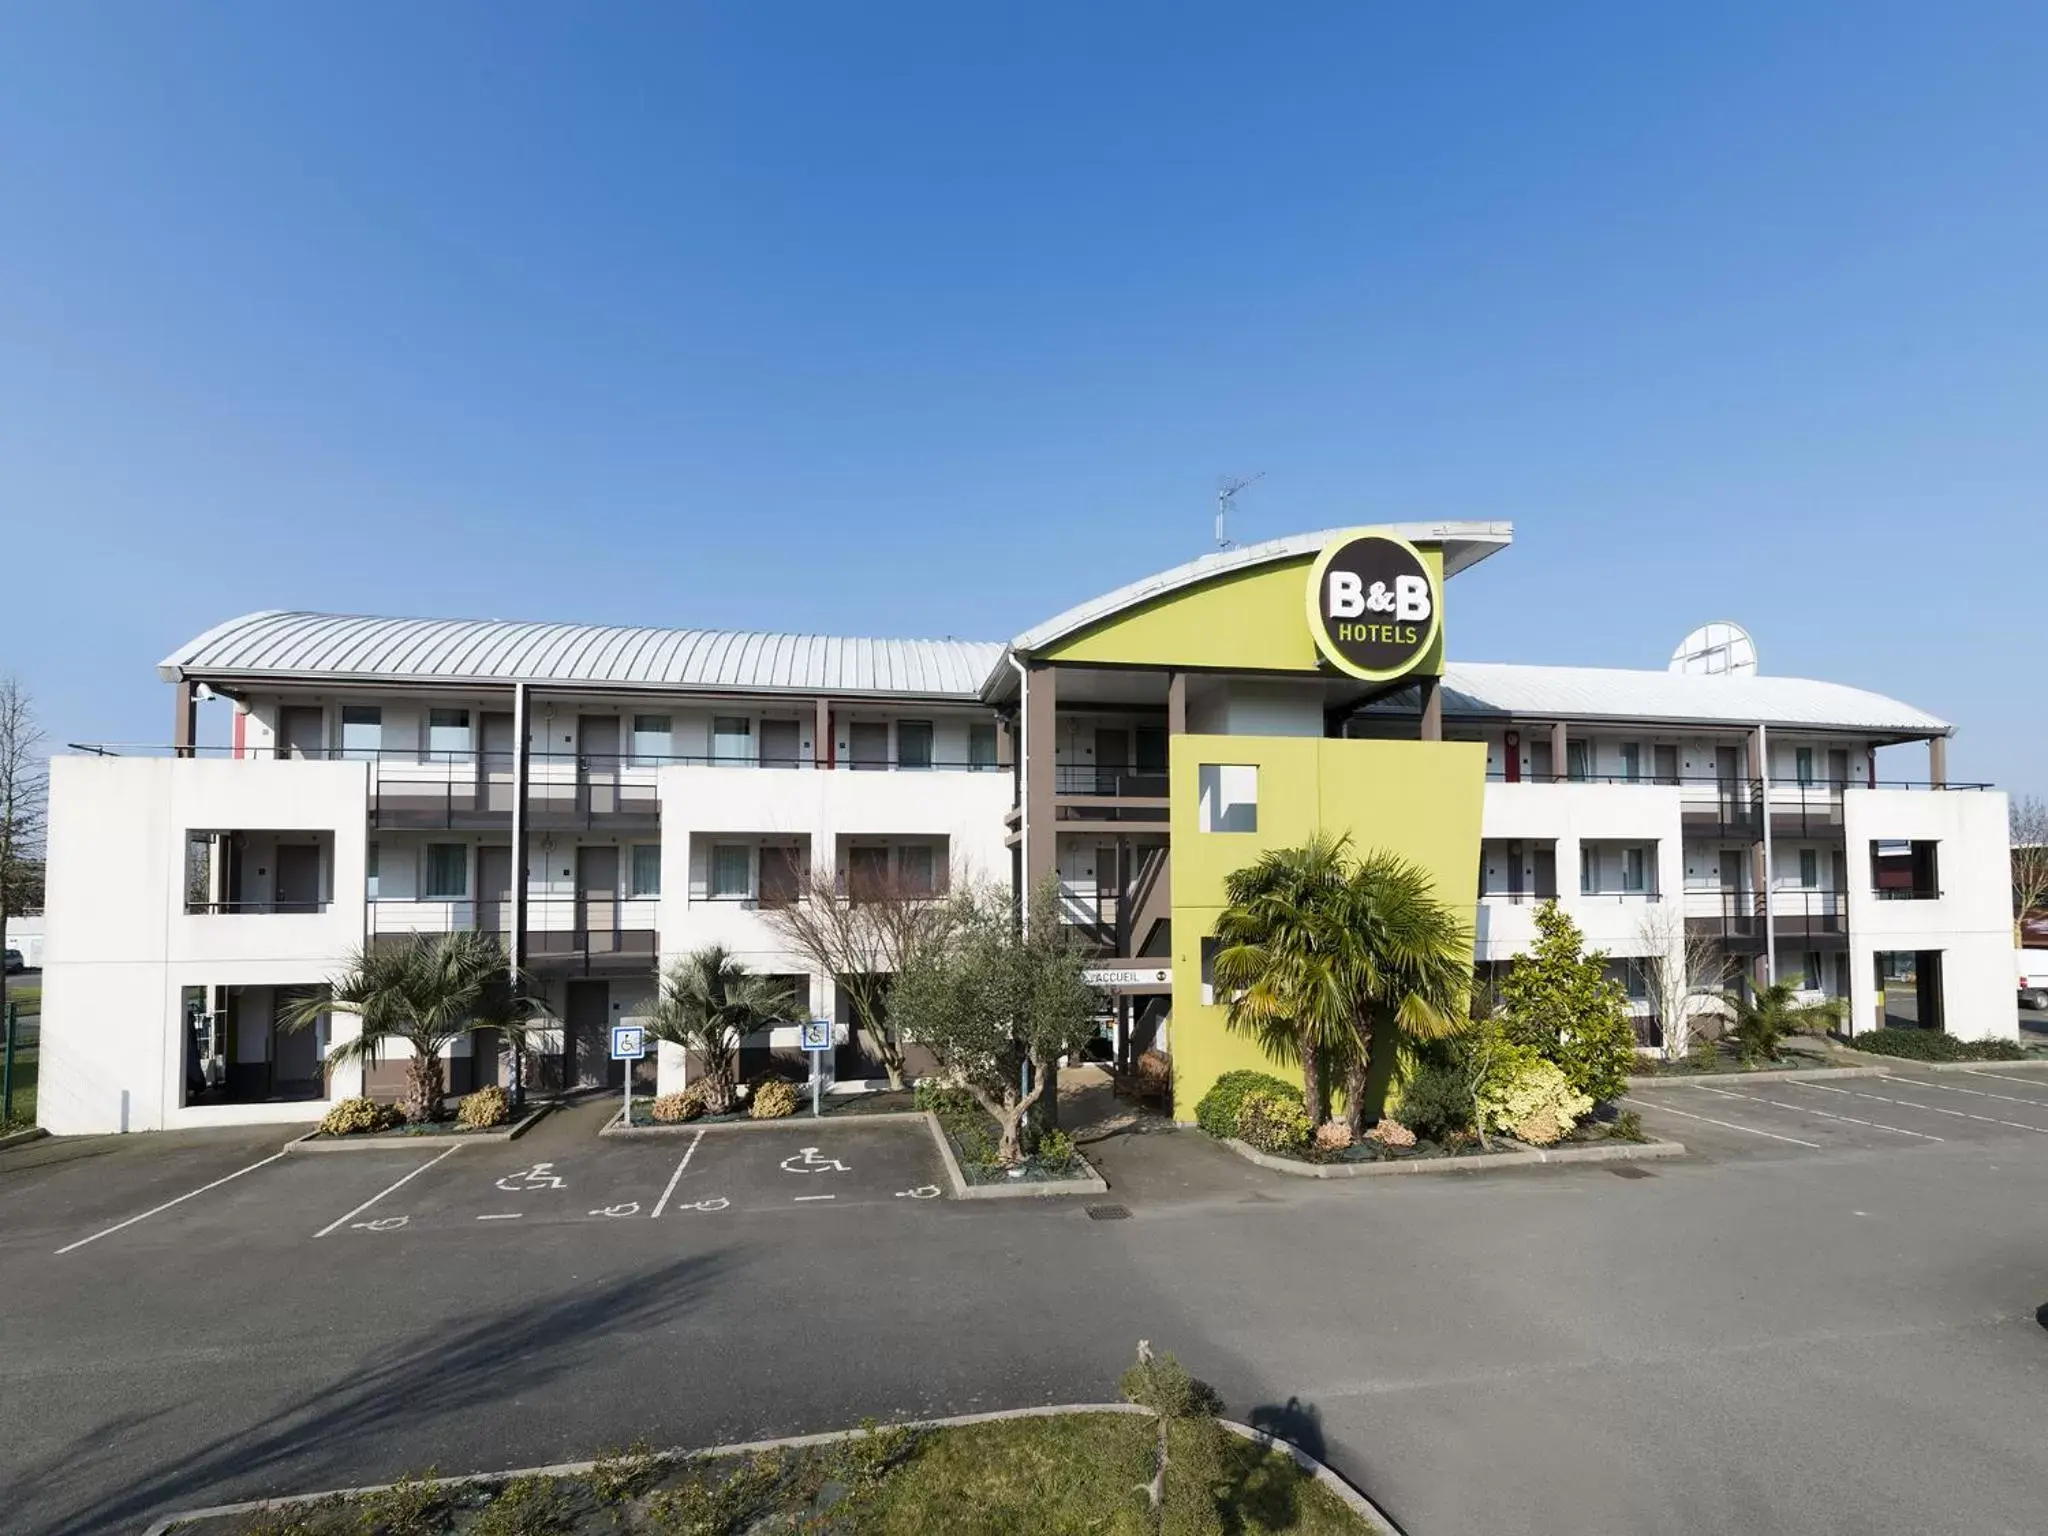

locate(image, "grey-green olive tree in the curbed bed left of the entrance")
[[889, 881, 1100, 1163]]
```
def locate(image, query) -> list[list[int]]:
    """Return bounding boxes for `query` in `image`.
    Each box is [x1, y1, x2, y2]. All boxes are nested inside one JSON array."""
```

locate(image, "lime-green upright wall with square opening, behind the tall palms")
[[1167, 741, 1487, 1120]]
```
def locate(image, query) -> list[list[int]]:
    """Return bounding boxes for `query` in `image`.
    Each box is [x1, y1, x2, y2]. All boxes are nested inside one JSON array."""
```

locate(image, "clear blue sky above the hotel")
[[0, 12, 2048, 791]]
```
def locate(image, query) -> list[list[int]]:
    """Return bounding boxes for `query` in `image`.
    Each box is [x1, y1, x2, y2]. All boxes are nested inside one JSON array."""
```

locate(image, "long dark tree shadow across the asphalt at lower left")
[[0, 1257, 717, 1536]]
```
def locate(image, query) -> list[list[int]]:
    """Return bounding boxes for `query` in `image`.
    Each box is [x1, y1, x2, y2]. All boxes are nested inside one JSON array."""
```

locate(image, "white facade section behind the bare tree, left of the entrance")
[[657, 765, 1012, 1094]]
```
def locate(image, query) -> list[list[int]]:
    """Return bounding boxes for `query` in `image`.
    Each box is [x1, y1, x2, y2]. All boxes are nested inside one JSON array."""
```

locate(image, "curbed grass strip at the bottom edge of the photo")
[[178, 1413, 1374, 1536]]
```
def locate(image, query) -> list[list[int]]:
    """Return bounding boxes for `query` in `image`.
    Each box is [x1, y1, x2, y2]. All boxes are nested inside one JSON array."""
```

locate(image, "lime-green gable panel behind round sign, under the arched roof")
[[1038, 549, 1444, 676]]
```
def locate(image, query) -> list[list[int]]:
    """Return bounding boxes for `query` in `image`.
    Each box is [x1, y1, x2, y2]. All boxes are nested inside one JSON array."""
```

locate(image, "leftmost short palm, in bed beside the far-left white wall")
[[279, 932, 528, 1122]]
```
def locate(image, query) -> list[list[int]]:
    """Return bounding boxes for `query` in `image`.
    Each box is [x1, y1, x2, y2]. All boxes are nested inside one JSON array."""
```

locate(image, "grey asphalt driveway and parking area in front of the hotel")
[[0, 1097, 2048, 1536]]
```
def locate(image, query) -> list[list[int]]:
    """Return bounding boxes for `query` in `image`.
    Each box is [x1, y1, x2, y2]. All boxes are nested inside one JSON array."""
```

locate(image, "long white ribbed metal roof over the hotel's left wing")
[[158, 610, 1004, 698]]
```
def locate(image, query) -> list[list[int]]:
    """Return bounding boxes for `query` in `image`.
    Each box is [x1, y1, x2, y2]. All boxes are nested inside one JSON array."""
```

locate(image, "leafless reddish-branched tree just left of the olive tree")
[[766, 864, 948, 1087]]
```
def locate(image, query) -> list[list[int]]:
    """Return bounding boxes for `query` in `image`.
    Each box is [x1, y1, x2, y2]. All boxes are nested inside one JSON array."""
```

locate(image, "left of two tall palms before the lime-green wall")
[[1212, 831, 1356, 1124]]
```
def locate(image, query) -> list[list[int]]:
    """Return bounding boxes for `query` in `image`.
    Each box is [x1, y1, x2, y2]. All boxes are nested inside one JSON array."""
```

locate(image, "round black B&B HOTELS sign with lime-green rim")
[[1309, 532, 1444, 682]]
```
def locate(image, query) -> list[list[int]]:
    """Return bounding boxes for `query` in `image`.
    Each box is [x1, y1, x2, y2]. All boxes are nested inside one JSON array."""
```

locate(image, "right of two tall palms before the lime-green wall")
[[1333, 852, 1473, 1137]]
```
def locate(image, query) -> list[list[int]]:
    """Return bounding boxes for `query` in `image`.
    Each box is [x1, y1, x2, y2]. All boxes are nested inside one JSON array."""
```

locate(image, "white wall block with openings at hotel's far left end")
[[37, 758, 367, 1133]]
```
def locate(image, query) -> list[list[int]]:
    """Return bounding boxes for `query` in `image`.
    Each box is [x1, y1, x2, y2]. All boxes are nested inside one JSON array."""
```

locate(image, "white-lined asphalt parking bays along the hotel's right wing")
[[1626, 1063, 2048, 1157]]
